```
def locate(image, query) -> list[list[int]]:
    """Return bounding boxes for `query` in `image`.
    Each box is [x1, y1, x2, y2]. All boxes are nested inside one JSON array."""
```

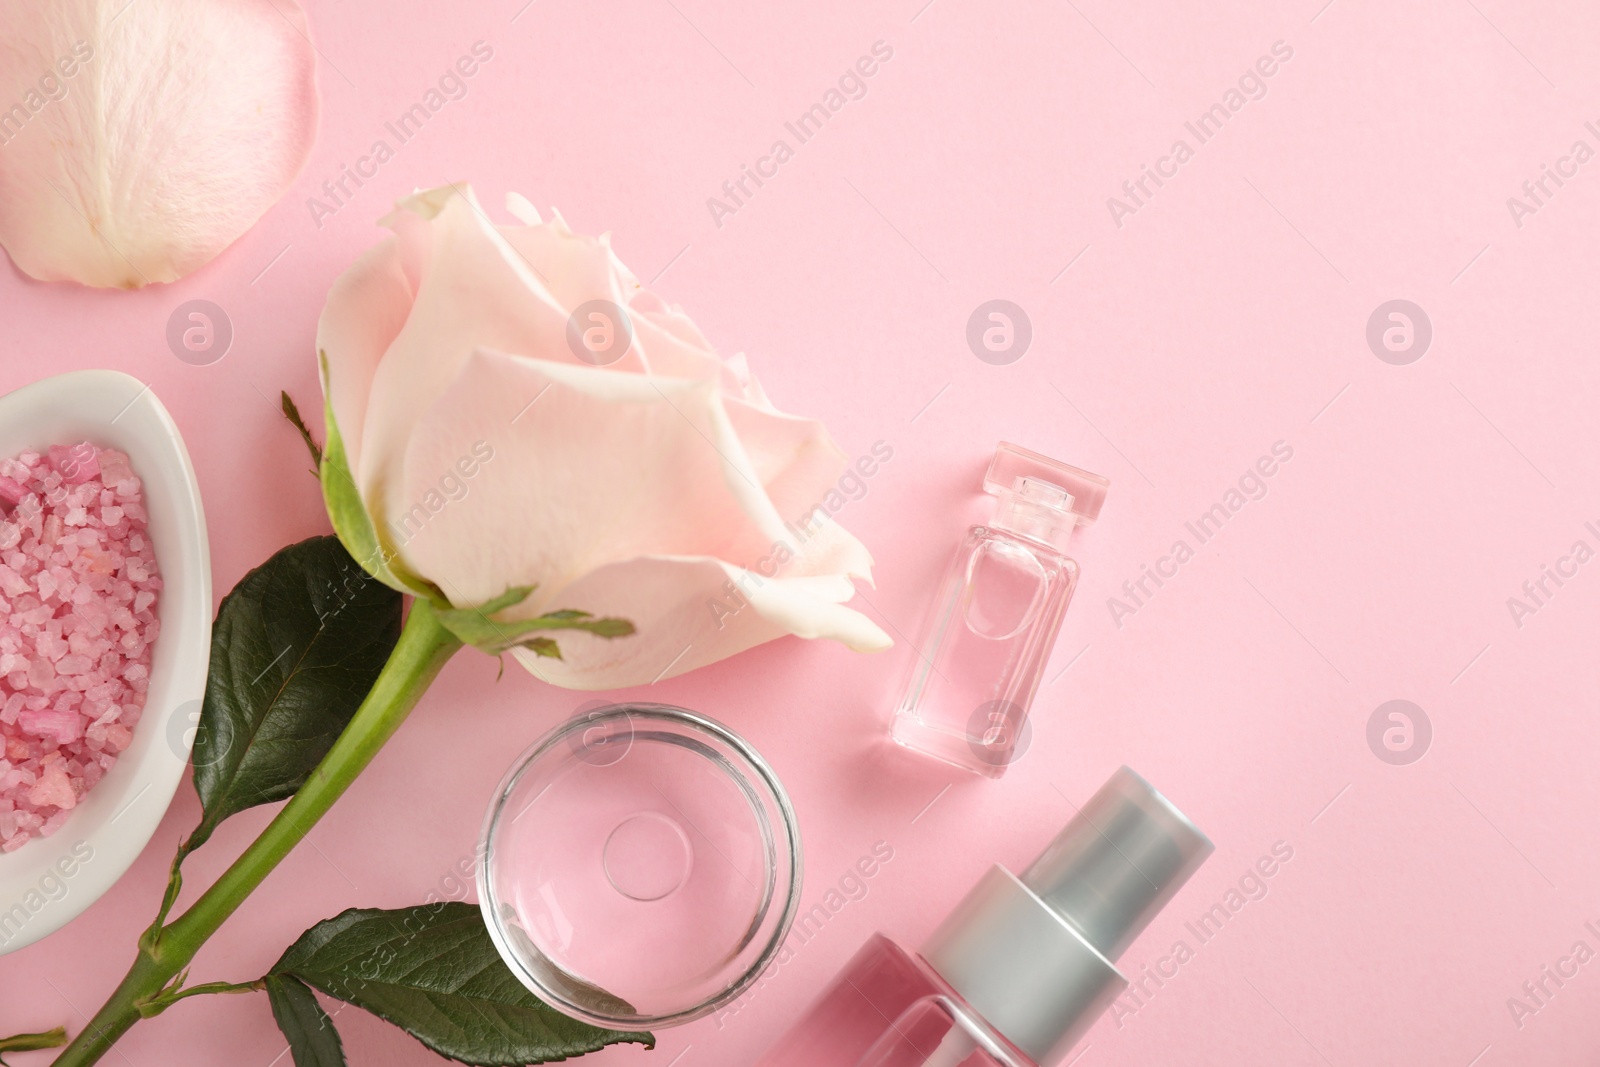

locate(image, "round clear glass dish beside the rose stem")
[[478, 704, 802, 1030]]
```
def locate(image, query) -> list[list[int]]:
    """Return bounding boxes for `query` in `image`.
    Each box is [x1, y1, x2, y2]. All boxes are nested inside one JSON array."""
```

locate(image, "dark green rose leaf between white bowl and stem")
[[182, 536, 400, 853]]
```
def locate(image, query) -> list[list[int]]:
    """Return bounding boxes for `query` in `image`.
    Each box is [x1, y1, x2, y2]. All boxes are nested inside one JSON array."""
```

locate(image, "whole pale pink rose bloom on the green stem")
[[318, 186, 890, 688]]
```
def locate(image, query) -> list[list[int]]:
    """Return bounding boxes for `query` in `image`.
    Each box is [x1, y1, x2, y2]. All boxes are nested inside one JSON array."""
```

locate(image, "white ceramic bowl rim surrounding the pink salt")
[[0, 371, 211, 955]]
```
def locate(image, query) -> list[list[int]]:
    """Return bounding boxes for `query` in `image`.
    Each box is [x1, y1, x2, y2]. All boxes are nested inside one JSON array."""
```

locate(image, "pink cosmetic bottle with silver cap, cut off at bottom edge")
[[758, 768, 1211, 1067]]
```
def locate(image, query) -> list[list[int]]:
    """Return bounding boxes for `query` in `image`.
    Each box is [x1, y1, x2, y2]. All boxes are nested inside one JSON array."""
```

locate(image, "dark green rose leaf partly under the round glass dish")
[[272, 901, 656, 1067]]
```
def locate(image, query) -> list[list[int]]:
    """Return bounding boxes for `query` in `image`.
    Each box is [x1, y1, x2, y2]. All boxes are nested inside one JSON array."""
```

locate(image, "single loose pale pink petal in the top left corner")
[[0, 0, 317, 288]]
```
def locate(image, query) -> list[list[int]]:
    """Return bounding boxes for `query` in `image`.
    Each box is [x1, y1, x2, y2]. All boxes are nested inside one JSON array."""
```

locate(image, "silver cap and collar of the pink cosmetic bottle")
[[922, 768, 1213, 1067]]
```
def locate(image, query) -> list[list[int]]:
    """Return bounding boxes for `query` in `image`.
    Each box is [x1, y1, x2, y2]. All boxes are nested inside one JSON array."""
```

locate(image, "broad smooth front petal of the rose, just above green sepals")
[[387, 350, 789, 617]]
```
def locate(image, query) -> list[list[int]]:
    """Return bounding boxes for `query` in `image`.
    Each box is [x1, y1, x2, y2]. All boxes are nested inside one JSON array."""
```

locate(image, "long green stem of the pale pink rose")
[[56, 600, 461, 1067]]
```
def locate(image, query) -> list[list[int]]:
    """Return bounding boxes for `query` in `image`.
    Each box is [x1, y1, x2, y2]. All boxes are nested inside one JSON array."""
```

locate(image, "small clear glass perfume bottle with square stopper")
[[891, 442, 1110, 777]]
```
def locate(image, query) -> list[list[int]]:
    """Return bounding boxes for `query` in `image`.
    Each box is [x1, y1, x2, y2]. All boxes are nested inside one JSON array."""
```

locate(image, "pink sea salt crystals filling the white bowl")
[[0, 442, 162, 853]]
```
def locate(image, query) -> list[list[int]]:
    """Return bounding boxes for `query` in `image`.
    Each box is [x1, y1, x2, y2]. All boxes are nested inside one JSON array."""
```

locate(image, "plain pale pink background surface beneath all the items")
[[0, 0, 1600, 1067]]
